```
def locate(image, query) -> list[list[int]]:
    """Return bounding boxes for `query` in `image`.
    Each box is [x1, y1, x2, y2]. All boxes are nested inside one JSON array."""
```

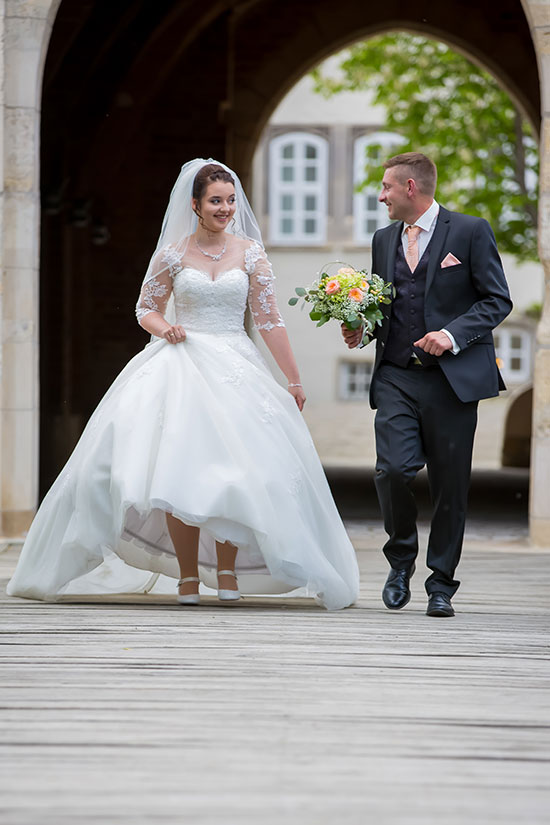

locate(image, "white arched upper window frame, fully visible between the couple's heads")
[[269, 132, 328, 246]]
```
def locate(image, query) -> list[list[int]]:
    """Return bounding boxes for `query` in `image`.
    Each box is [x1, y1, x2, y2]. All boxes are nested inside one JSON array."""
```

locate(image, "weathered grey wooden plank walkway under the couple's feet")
[[0, 528, 550, 825]]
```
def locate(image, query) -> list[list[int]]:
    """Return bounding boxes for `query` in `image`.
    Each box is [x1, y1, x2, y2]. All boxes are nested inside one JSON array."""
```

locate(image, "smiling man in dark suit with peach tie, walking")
[[342, 152, 512, 616]]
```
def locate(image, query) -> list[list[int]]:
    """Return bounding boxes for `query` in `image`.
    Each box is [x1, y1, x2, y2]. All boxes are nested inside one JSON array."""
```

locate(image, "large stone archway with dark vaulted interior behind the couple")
[[2, 0, 550, 548]]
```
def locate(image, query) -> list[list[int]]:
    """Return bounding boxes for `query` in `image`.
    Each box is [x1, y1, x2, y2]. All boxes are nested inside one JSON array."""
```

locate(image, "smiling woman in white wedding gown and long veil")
[[8, 159, 359, 610]]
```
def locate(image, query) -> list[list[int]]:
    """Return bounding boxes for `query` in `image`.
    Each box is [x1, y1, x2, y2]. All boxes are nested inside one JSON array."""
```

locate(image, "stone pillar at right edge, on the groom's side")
[[523, 0, 550, 547]]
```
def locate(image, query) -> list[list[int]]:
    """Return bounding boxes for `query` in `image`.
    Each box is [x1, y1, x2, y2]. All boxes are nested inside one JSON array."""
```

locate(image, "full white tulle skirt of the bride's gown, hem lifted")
[[8, 330, 359, 609]]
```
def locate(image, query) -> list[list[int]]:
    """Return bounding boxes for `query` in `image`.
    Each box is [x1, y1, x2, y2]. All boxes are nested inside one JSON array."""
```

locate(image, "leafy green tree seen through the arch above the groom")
[[313, 32, 538, 260]]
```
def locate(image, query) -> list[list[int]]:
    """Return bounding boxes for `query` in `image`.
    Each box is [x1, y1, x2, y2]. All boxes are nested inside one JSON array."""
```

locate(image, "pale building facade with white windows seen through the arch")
[[253, 67, 544, 468]]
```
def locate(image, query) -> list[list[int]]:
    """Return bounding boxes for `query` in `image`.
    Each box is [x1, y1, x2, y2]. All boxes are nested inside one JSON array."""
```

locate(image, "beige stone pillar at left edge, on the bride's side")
[[0, 0, 60, 536]]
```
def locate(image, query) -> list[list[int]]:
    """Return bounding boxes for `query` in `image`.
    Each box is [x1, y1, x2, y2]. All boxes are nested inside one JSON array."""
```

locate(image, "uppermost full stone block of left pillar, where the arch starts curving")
[[4, 17, 51, 110]]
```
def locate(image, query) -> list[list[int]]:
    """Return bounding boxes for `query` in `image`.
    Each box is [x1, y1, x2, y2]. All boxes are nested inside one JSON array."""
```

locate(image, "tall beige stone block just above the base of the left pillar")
[[1, 409, 38, 512]]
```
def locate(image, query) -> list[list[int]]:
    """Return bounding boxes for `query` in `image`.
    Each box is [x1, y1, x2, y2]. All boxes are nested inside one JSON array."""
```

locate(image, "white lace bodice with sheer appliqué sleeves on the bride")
[[136, 243, 284, 333]]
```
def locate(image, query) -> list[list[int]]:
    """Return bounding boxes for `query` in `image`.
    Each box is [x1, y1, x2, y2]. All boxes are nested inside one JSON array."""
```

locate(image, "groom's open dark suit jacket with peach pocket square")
[[371, 207, 512, 406]]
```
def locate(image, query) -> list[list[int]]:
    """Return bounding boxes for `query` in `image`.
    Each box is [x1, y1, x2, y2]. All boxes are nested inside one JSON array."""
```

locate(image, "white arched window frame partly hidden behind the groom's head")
[[353, 132, 406, 246]]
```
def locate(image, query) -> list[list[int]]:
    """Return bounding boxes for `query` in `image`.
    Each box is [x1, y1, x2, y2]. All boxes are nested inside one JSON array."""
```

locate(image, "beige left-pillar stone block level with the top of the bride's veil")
[[4, 108, 40, 192]]
